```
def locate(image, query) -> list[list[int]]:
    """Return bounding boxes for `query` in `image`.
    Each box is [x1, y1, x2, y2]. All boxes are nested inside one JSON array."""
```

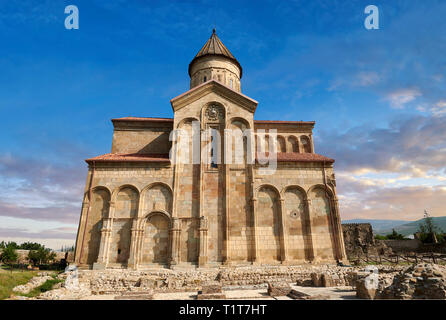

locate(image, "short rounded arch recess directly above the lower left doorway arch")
[[141, 182, 173, 214]]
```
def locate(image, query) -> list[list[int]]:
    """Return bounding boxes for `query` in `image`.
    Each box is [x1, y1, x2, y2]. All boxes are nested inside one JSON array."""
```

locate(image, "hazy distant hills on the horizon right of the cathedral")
[[342, 217, 446, 236]]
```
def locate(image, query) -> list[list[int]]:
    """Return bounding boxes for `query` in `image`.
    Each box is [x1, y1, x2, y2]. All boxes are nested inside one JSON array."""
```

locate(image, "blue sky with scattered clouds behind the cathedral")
[[0, 0, 446, 249]]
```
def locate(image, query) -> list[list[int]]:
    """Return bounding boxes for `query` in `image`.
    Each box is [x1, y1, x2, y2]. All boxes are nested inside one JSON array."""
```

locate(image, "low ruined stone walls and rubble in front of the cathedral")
[[15, 264, 446, 300]]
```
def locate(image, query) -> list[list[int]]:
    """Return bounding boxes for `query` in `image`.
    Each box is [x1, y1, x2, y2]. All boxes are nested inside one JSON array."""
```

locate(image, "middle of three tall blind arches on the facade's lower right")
[[282, 185, 312, 261]]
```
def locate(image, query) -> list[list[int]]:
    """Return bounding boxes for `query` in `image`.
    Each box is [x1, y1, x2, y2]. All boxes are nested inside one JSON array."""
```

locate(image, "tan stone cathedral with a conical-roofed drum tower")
[[75, 30, 345, 269]]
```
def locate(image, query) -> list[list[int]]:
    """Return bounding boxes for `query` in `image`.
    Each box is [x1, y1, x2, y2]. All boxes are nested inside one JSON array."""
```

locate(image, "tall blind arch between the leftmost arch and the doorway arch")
[[109, 185, 139, 264]]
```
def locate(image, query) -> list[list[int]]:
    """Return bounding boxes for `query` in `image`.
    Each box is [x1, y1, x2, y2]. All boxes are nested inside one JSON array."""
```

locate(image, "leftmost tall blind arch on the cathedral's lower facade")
[[81, 186, 111, 265]]
